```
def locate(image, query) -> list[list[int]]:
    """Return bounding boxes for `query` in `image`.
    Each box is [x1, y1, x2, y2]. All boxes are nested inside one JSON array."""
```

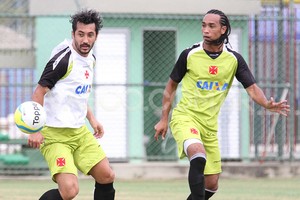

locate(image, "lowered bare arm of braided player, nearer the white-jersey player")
[[154, 79, 178, 140]]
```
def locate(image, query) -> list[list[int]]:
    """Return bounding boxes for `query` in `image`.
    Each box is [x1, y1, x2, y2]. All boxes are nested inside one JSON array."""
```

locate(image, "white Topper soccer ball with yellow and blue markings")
[[14, 101, 46, 134]]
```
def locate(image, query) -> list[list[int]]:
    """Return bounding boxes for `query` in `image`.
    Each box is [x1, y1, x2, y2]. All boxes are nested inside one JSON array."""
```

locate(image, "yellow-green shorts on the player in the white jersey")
[[40, 126, 106, 181]]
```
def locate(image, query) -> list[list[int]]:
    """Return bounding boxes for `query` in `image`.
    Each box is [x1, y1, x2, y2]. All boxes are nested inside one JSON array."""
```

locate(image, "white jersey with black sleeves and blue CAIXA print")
[[39, 41, 95, 128]]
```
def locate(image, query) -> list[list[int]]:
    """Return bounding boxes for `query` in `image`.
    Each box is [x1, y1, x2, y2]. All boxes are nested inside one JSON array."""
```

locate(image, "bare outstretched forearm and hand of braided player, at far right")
[[246, 84, 290, 116]]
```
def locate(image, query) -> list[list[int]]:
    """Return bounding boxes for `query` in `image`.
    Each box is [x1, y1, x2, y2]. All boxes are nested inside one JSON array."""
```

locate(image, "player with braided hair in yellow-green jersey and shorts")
[[154, 9, 289, 200]]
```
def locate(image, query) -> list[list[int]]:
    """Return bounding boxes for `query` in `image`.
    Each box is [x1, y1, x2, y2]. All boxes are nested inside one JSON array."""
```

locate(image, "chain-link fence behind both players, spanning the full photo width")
[[0, 0, 300, 174]]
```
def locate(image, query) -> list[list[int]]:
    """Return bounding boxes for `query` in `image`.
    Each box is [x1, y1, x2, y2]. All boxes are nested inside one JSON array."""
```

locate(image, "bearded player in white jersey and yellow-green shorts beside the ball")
[[28, 10, 115, 200]]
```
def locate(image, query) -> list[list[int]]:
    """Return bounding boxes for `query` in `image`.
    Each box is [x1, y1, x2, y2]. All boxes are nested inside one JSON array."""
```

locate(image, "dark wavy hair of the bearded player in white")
[[70, 9, 103, 34]]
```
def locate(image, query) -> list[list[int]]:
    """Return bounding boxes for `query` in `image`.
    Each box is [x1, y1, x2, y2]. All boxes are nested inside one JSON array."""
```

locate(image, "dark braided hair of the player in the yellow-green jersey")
[[206, 9, 231, 44]]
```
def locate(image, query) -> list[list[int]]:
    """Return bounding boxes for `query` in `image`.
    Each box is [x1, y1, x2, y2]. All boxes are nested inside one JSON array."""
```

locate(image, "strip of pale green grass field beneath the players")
[[0, 177, 300, 200]]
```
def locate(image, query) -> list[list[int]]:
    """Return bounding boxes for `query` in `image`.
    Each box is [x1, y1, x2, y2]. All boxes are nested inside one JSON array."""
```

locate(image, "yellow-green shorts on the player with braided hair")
[[170, 115, 222, 175]]
